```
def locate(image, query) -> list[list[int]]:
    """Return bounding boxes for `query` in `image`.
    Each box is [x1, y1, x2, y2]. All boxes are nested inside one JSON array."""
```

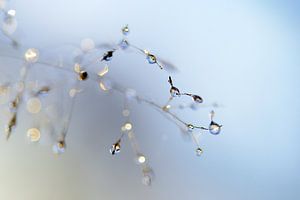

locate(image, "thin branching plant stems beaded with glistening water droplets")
[[0, 18, 222, 186]]
